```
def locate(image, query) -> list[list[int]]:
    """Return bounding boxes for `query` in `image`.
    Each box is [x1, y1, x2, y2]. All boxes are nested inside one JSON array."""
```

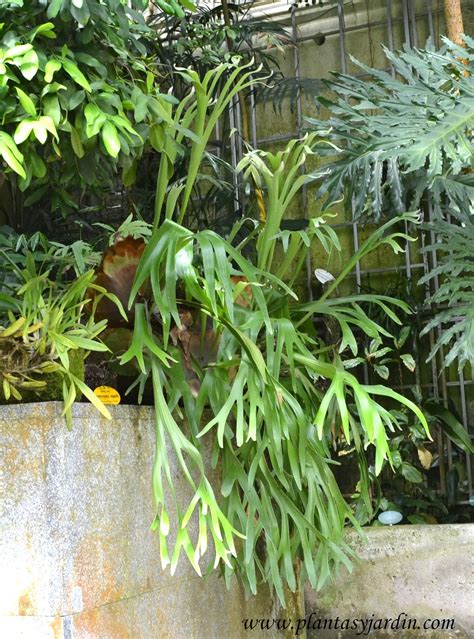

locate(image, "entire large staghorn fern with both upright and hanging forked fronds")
[[108, 70, 434, 600]]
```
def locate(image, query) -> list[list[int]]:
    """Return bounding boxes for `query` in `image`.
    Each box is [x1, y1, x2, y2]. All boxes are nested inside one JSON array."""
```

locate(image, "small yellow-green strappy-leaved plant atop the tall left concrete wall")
[[0, 235, 123, 426]]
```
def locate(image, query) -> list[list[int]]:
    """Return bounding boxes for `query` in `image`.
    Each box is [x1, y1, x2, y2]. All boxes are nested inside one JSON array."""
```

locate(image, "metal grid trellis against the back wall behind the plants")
[[221, 0, 474, 504]]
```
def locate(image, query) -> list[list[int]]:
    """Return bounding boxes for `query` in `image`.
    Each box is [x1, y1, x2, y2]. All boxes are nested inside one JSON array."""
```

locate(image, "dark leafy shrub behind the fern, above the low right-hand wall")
[[334, 280, 474, 524]]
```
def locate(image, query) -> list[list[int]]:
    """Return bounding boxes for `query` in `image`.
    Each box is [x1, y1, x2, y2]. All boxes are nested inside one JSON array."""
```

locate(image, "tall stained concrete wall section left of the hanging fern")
[[0, 402, 275, 639]]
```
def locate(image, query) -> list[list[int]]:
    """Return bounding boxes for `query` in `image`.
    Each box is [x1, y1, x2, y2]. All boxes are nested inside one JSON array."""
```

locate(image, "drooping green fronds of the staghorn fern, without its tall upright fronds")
[[116, 215, 427, 602]]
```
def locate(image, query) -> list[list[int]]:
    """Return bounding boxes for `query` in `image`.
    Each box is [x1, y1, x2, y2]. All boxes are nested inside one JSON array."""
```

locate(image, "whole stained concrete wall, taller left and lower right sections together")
[[0, 402, 474, 639]]
